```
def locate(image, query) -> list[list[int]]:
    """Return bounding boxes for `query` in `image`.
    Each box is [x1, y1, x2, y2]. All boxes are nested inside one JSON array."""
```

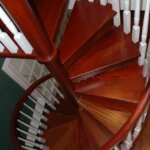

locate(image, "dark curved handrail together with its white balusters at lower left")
[[11, 74, 64, 150]]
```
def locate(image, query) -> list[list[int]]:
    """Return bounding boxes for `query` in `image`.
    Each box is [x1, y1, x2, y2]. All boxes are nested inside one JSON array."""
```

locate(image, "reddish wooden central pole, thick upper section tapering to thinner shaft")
[[0, 0, 77, 103]]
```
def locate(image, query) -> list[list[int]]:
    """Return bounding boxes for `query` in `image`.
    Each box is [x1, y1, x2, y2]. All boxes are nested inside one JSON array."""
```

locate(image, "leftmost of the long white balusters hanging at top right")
[[112, 0, 121, 27]]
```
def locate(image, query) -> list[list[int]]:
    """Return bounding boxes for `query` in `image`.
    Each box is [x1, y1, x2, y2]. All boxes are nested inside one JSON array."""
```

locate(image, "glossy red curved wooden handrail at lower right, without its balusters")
[[100, 85, 150, 150]]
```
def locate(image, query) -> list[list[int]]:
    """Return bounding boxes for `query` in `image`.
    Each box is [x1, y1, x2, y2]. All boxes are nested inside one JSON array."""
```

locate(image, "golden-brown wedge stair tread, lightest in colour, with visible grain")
[[80, 101, 130, 134]]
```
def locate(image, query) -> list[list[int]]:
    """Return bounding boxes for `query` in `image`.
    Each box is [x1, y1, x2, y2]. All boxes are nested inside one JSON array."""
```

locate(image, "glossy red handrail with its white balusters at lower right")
[[100, 85, 150, 150]]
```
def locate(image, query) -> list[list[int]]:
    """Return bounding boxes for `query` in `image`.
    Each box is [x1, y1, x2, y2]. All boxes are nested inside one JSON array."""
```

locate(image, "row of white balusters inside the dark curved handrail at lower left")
[[16, 75, 64, 150]]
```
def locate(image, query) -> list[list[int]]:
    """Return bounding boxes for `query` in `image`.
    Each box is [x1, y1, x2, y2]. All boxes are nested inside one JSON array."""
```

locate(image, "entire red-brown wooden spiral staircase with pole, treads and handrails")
[[0, 0, 150, 150]]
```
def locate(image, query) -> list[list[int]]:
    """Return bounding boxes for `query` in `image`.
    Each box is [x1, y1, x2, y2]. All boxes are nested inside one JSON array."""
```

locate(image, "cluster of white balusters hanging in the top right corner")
[[85, 0, 150, 83]]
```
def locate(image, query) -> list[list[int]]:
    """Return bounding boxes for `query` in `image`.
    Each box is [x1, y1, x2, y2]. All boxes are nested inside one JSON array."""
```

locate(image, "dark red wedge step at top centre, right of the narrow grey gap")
[[60, 0, 115, 67]]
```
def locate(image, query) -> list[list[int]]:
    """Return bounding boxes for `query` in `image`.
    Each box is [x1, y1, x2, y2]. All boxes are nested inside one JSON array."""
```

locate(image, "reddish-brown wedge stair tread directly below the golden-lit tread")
[[80, 109, 113, 149]]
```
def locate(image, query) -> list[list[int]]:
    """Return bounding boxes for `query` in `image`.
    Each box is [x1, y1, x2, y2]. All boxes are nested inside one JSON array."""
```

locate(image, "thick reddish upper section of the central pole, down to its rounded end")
[[0, 0, 56, 62]]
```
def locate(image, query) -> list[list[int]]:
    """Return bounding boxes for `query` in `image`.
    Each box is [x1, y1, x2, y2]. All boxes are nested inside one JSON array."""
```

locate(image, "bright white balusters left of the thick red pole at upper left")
[[0, 6, 33, 54]]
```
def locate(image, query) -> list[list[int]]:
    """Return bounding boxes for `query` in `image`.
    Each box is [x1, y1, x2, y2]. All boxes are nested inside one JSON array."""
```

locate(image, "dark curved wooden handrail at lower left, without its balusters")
[[10, 74, 52, 150]]
